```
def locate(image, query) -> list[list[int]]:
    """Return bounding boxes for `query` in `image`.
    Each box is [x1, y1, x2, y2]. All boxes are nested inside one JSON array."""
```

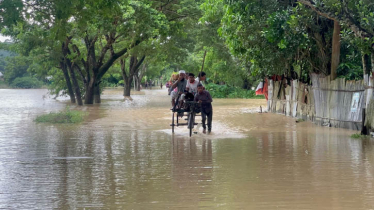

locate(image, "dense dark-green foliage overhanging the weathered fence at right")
[[202, 0, 374, 79]]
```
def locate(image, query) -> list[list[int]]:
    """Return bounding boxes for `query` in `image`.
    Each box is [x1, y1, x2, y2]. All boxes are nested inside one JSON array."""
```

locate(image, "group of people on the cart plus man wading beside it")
[[166, 70, 213, 133]]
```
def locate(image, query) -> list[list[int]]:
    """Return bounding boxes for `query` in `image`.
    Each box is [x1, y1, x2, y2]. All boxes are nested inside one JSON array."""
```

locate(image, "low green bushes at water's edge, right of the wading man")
[[205, 83, 265, 99]]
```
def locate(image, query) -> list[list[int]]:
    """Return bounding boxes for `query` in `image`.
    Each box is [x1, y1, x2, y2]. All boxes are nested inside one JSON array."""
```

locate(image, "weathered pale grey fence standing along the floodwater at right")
[[268, 74, 366, 130]]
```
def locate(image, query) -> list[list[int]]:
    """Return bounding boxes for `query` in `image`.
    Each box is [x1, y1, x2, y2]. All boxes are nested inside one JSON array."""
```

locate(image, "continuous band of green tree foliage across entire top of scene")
[[0, 0, 374, 97]]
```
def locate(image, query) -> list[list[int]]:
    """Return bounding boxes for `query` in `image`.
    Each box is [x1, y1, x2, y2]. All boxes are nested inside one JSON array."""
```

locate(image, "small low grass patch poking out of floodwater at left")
[[35, 107, 85, 124]]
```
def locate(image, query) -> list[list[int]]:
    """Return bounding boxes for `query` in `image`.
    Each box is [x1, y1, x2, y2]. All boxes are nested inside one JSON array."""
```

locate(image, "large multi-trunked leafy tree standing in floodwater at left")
[[2, 0, 202, 104]]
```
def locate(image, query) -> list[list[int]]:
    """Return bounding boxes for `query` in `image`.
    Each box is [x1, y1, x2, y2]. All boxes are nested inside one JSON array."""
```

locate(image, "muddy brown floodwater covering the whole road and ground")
[[0, 89, 374, 210]]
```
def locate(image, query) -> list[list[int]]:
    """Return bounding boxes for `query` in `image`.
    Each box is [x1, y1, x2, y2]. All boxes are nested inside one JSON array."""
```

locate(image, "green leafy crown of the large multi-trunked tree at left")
[[0, 0, 200, 100]]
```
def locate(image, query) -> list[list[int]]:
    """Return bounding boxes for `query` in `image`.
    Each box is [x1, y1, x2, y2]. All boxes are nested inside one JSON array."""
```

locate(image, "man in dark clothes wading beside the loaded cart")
[[195, 84, 213, 133]]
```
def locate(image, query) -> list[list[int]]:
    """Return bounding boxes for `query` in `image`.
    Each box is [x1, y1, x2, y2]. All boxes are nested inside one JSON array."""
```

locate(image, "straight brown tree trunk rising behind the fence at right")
[[331, 20, 341, 80]]
